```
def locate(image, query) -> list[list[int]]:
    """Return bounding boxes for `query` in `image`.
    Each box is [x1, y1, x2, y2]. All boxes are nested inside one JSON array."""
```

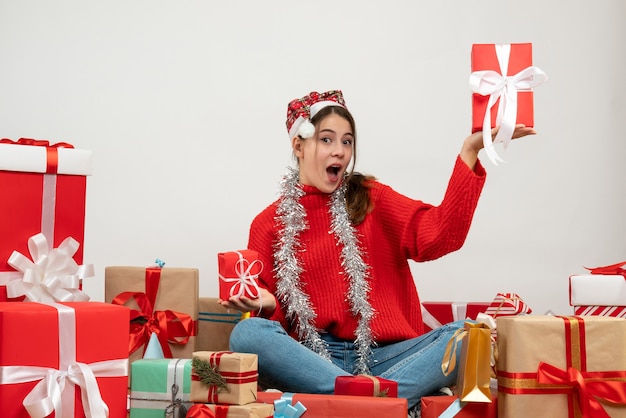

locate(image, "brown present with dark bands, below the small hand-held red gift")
[[196, 297, 241, 351]]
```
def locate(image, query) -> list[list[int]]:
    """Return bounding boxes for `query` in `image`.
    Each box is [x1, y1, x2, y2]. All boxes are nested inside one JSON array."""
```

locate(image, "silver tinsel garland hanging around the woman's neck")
[[274, 168, 374, 374]]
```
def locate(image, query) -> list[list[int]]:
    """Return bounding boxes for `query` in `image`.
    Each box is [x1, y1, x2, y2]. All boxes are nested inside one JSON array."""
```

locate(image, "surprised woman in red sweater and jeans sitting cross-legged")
[[221, 90, 535, 407]]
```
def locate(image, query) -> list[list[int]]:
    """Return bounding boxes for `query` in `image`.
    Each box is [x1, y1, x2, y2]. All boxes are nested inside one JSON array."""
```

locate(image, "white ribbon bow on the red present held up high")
[[469, 44, 548, 165]]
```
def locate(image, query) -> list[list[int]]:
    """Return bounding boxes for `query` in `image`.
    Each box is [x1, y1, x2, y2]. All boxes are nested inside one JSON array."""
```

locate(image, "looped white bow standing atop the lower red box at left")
[[7, 233, 94, 303]]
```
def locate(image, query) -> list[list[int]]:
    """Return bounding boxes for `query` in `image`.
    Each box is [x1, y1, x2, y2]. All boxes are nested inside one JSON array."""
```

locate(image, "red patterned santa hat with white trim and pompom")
[[287, 90, 346, 139]]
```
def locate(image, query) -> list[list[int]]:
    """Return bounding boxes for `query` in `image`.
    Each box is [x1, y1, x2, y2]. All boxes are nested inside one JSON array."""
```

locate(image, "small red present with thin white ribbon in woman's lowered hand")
[[217, 250, 263, 300]]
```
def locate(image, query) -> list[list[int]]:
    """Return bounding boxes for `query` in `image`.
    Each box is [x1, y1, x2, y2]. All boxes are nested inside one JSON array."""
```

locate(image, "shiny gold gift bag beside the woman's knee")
[[441, 322, 491, 403]]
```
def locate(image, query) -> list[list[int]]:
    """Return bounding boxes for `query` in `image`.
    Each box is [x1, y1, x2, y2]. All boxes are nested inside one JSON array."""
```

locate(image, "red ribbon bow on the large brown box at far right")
[[537, 362, 626, 418]]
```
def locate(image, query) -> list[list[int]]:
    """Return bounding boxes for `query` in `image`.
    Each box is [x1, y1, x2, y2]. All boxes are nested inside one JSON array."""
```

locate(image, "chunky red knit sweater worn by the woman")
[[248, 157, 486, 344]]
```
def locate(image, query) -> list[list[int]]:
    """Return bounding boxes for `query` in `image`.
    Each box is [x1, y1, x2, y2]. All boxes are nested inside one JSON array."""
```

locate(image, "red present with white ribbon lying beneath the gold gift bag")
[[421, 391, 498, 418]]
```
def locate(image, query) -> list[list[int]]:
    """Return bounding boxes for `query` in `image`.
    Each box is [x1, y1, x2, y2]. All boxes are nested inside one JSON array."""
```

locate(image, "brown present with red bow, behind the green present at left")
[[104, 266, 199, 362]]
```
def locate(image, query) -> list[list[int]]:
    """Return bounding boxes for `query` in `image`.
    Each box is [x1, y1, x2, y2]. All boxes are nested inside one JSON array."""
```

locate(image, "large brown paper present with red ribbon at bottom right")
[[496, 315, 626, 418]]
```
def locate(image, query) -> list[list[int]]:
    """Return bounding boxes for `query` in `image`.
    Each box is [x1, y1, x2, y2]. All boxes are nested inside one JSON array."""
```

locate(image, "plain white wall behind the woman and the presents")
[[0, 0, 626, 314]]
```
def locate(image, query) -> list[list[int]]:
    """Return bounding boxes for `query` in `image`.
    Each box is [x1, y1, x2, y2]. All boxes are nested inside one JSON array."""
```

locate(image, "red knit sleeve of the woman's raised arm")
[[372, 156, 486, 261]]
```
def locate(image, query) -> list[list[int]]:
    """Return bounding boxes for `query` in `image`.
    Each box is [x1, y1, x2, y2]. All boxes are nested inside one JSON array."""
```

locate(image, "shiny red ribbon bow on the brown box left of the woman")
[[111, 267, 196, 358]]
